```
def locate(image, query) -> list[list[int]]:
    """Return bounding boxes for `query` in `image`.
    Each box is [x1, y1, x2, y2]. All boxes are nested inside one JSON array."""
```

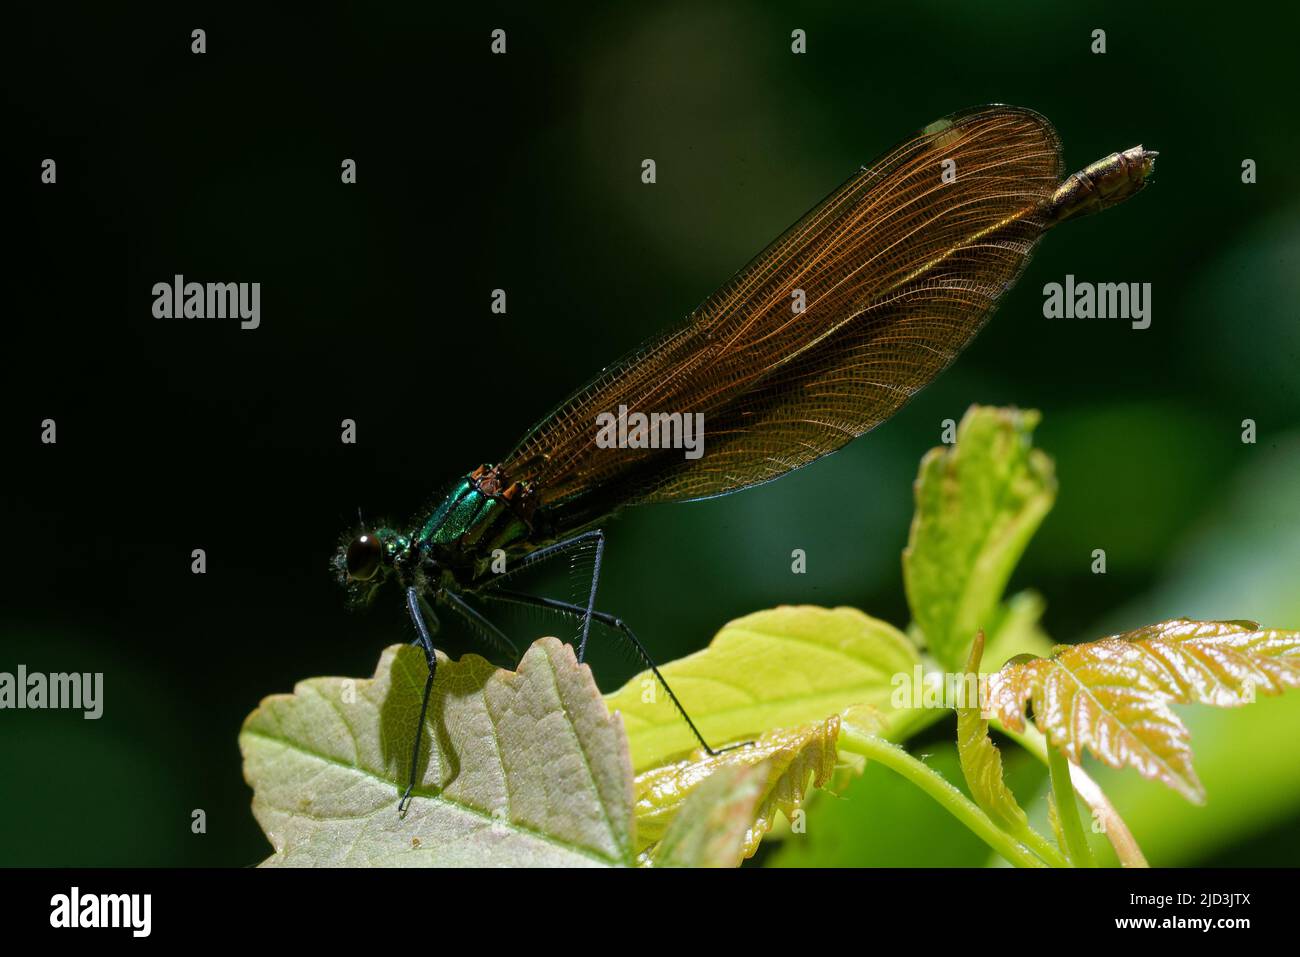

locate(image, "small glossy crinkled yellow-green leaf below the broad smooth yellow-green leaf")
[[634, 716, 842, 866]]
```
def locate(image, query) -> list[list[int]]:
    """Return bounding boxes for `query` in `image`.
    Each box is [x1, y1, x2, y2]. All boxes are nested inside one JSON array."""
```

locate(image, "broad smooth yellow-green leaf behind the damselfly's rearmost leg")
[[606, 606, 926, 772]]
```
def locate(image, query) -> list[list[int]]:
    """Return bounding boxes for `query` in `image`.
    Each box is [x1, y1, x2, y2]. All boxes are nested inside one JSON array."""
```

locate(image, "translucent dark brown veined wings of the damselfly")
[[502, 107, 1063, 506]]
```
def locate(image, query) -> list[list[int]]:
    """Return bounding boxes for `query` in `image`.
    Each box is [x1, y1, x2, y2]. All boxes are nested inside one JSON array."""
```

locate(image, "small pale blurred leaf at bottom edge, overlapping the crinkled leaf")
[[649, 762, 767, 867]]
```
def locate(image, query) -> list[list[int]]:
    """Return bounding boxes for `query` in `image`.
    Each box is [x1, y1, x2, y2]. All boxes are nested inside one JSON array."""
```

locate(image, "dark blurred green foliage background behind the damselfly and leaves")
[[0, 1, 1300, 865]]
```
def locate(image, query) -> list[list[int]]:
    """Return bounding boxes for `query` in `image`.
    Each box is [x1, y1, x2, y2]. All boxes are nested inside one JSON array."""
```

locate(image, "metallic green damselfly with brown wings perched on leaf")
[[334, 105, 1156, 810]]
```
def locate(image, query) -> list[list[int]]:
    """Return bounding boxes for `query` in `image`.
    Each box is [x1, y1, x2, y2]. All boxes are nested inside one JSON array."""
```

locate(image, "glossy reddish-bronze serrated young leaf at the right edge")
[[988, 618, 1300, 804]]
